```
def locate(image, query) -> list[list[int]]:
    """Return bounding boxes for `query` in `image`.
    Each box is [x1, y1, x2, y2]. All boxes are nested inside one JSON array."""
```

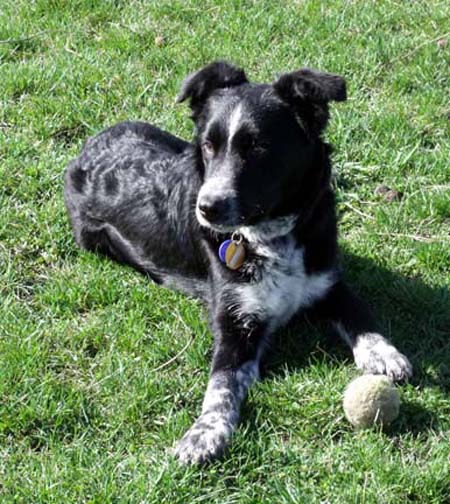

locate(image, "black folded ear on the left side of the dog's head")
[[177, 61, 248, 117]]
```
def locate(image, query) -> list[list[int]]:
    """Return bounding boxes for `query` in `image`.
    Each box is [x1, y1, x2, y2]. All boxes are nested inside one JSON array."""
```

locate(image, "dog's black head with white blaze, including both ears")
[[178, 62, 346, 232]]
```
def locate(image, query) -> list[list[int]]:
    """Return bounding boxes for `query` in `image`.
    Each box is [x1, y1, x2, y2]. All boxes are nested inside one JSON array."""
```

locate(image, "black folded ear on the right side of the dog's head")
[[273, 68, 347, 134]]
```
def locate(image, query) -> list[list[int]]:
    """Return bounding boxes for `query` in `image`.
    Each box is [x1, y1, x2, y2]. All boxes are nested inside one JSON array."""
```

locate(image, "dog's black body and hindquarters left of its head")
[[64, 122, 207, 291]]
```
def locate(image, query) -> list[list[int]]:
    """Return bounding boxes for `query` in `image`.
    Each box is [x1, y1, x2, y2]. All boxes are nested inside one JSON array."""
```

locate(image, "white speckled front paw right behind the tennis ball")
[[353, 333, 412, 381]]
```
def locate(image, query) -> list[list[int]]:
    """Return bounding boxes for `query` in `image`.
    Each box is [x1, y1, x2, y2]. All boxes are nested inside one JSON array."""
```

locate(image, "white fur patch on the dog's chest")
[[235, 235, 335, 330]]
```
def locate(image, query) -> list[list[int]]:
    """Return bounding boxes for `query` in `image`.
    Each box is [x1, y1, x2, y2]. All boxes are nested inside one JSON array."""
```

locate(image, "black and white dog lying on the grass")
[[65, 62, 412, 463]]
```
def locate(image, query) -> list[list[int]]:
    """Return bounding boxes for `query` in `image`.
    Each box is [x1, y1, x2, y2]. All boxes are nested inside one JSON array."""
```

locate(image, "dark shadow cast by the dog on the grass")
[[253, 252, 450, 436]]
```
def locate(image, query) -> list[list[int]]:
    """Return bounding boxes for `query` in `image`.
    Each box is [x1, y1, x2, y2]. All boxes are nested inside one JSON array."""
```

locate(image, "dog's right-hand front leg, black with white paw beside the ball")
[[318, 282, 412, 381]]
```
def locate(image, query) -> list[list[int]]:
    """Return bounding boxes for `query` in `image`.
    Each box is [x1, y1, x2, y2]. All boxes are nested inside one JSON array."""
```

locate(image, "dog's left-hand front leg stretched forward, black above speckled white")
[[175, 316, 264, 464]]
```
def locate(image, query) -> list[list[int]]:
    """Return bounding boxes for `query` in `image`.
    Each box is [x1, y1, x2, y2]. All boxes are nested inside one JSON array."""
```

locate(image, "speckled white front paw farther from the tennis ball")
[[175, 413, 233, 464]]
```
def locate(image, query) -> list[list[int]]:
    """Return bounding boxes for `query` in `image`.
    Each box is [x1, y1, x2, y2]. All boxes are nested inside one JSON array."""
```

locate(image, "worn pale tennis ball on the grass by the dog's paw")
[[344, 374, 400, 429]]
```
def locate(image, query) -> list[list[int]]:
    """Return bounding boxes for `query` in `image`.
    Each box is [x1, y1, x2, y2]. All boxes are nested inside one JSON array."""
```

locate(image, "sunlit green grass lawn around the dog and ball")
[[0, 0, 450, 504]]
